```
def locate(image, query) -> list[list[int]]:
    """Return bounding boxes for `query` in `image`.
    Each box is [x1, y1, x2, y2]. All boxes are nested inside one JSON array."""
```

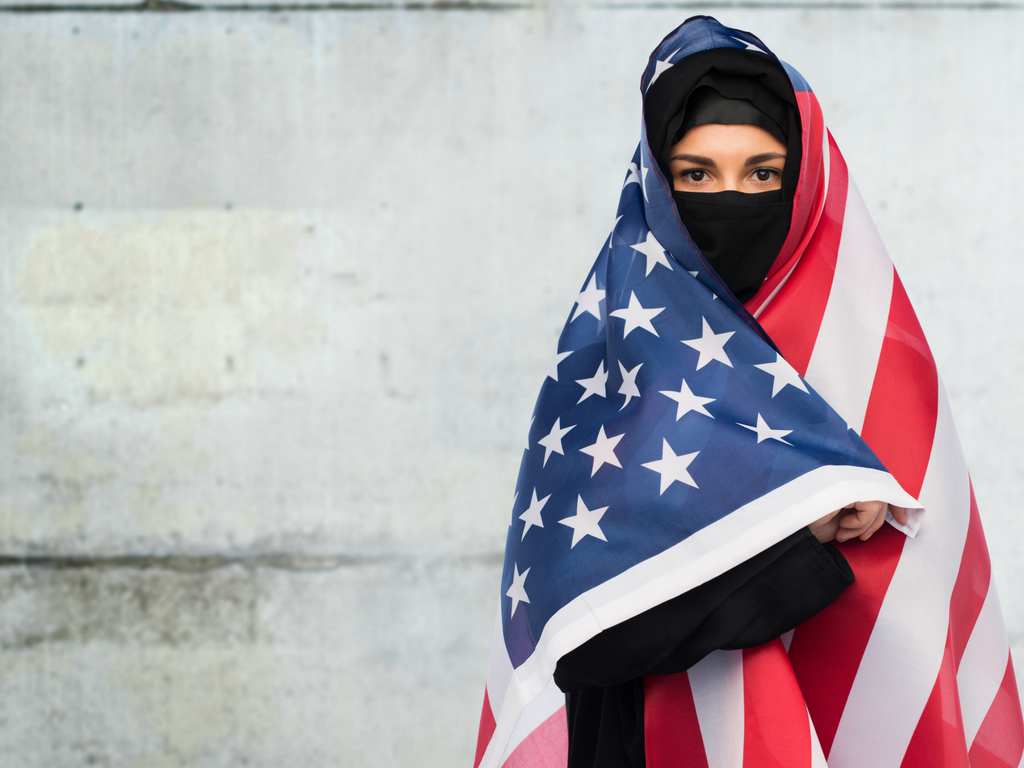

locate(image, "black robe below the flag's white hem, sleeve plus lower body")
[[555, 528, 854, 768]]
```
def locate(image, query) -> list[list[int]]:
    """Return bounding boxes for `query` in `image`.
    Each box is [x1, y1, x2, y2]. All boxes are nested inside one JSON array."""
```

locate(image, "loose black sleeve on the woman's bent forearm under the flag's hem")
[[555, 528, 854, 691]]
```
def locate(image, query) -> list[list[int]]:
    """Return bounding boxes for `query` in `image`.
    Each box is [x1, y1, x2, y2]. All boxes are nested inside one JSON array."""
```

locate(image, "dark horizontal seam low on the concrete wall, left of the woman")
[[0, 552, 503, 572]]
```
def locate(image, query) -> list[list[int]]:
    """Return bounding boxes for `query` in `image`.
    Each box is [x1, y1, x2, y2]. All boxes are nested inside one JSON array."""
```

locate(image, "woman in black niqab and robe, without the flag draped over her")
[[554, 67, 906, 768]]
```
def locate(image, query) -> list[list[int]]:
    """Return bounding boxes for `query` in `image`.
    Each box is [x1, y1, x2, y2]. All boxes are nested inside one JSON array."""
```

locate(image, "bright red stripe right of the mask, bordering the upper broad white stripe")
[[761, 136, 848, 376]]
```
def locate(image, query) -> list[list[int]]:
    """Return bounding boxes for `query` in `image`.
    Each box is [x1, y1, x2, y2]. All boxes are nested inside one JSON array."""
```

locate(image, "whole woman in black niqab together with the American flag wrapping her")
[[477, 17, 1024, 768]]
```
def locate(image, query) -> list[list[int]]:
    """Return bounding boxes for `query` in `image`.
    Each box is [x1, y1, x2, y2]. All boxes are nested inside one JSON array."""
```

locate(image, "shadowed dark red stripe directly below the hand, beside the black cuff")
[[790, 525, 906, 757]]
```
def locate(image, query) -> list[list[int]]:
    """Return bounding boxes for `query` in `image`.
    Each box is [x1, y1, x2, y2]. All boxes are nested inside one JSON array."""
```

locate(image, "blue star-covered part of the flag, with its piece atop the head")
[[502, 30, 884, 667]]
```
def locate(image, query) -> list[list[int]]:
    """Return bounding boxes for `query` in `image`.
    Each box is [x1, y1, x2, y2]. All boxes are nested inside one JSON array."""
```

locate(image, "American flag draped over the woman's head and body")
[[476, 16, 1024, 768]]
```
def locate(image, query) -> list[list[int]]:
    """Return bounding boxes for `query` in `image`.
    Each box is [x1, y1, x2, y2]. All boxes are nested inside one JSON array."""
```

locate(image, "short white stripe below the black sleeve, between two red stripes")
[[686, 650, 743, 768]]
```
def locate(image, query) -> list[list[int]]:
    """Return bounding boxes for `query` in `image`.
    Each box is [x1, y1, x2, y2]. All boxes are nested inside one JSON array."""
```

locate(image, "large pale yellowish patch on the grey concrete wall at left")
[[11, 211, 327, 409]]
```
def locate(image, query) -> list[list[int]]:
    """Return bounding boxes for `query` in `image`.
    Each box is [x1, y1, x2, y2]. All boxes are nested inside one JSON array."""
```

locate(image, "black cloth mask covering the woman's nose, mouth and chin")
[[672, 189, 793, 302]]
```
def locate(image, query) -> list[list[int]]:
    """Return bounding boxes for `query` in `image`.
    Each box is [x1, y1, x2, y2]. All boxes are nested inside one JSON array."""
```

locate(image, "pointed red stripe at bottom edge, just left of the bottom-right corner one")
[[901, 634, 971, 768]]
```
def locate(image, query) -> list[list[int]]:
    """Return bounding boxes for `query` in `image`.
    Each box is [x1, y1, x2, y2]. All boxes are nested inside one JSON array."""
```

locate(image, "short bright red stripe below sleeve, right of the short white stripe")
[[743, 640, 811, 768]]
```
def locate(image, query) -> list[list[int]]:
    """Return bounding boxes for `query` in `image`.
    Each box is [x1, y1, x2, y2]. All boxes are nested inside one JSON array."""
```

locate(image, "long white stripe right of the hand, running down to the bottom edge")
[[828, 381, 971, 768]]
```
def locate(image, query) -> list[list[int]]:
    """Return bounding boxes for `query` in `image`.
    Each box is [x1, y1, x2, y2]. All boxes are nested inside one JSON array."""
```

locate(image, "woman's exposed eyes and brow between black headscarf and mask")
[[669, 123, 785, 193]]
